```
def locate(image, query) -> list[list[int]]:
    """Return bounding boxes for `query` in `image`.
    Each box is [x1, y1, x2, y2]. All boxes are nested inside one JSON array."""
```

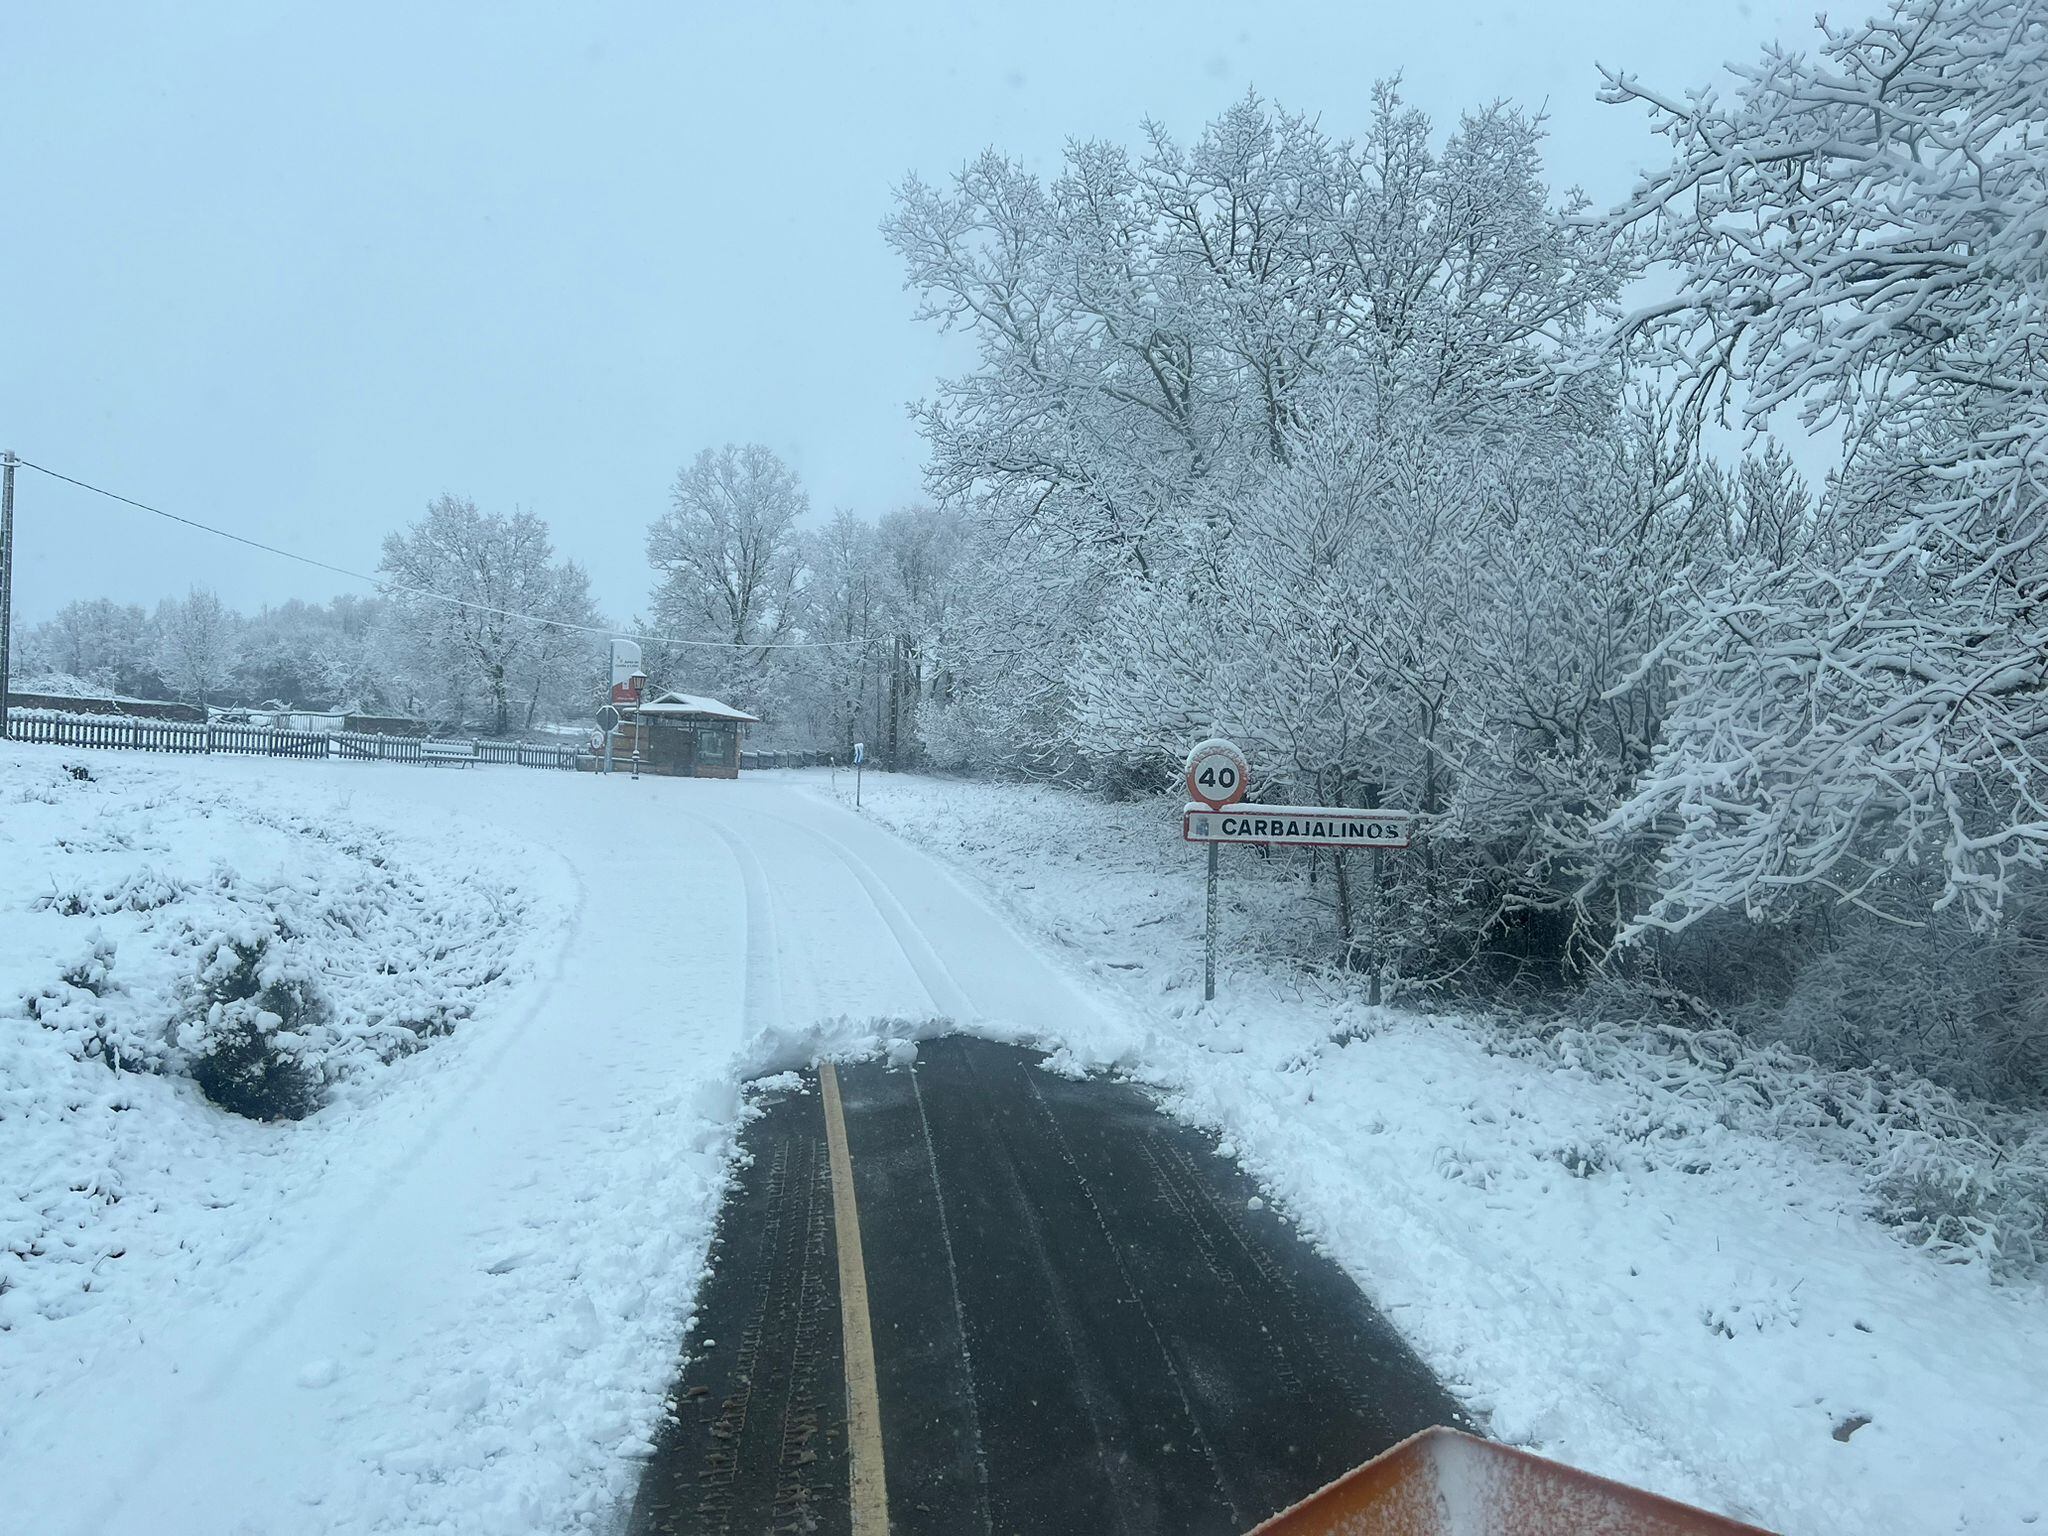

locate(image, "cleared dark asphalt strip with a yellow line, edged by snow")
[[633, 1036, 1464, 1536]]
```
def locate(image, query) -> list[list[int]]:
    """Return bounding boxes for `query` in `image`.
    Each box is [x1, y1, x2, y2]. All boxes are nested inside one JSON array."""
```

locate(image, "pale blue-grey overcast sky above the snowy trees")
[[0, 0, 1812, 621]]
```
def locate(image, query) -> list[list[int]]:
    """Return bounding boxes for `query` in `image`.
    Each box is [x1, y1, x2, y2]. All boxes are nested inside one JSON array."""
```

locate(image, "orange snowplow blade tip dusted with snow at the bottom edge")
[[1251, 1427, 1769, 1536]]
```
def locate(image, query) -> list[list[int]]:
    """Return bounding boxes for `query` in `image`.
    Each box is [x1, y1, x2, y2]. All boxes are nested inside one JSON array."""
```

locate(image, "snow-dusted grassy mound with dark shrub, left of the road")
[[0, 743, 549, 1368]]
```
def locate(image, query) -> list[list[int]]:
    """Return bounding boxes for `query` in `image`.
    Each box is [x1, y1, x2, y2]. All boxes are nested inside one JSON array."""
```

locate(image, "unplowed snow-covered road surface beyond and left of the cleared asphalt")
[[0, 762, 1122, 1536]]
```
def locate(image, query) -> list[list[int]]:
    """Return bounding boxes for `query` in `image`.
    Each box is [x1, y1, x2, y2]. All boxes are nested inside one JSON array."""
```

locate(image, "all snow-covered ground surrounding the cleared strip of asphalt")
[[0, 748, 2048, 1534]]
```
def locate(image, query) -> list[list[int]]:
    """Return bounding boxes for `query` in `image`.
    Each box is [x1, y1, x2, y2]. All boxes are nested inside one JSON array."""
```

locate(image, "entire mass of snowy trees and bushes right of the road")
[[847, 0, 2048, 1268]]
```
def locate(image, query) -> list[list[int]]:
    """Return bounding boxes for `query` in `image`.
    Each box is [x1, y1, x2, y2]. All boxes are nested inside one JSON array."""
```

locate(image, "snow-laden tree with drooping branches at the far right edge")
[[1606, 0, 2048, 928]]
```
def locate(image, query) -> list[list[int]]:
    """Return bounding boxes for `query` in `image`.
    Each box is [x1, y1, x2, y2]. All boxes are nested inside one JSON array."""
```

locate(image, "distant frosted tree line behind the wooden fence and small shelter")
[[14, 473, 963, 766]]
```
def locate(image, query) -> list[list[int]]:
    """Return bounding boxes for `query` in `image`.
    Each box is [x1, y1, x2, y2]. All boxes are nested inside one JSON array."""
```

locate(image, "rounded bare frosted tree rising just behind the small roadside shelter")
[[647, 442, 811, 709]]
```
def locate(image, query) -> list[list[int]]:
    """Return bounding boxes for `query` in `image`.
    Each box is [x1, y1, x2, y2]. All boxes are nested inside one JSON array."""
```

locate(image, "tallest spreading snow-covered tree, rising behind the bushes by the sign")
[[885, 86, 1620, 782]]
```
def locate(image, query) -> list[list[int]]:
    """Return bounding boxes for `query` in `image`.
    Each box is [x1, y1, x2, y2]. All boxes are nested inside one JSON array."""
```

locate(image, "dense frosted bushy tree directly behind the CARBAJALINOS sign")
[[1073, 385, 1690, 975]]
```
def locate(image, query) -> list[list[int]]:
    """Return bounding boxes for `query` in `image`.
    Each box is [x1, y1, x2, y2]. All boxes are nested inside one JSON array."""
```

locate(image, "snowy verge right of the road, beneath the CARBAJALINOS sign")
[[805, 774, 2048, 1534]]
